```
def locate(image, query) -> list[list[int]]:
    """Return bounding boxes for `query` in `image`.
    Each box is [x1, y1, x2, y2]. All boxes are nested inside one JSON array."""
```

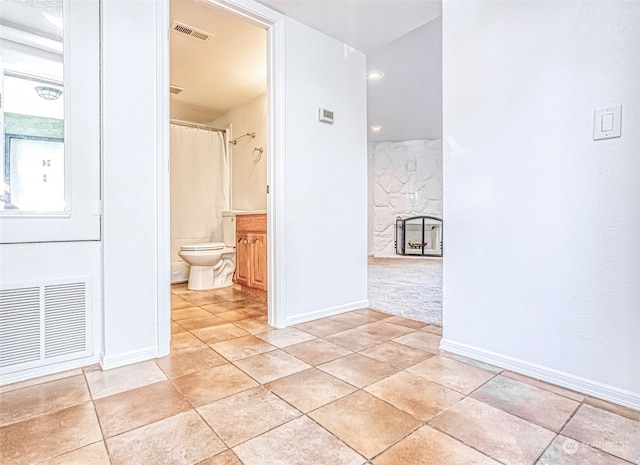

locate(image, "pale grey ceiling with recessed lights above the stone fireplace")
[[259, 0, 442, 142]]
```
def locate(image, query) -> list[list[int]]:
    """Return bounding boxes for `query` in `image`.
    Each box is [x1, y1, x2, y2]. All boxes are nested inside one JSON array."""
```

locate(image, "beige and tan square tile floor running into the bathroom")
[[0, 285, 640, 465]]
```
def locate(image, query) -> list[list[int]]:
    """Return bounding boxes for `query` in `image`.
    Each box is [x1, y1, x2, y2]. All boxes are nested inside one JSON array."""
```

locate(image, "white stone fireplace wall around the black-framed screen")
[[370, 139, 442, 257]]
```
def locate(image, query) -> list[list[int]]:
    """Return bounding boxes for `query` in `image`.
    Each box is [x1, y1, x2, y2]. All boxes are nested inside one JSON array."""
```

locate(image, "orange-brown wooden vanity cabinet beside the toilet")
[[235, 214, 267, 291]]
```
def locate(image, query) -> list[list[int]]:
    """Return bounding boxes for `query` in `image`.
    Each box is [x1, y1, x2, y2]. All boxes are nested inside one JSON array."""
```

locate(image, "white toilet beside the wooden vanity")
[[178, 212, 236, 291]]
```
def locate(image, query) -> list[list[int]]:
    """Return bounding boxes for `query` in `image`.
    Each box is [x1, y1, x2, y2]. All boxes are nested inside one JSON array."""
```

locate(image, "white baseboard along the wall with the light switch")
[[440, 339, 640, 410]]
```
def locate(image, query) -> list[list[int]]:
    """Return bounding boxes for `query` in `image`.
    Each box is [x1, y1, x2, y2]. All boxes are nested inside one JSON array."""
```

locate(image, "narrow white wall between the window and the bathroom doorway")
[[101, 0, 170, 367]]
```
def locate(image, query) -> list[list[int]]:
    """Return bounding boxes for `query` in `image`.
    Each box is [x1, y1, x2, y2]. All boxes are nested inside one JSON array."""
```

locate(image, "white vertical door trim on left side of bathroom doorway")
[[156, 2, 171, 356]]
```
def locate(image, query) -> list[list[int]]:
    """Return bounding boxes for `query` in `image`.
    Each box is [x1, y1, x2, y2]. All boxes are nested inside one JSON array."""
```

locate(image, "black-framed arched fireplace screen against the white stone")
[[396, 216, 442, 257]]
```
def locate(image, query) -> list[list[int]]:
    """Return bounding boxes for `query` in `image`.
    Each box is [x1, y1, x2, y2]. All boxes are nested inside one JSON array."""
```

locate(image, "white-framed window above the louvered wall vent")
[[0, 0, 100, 243]]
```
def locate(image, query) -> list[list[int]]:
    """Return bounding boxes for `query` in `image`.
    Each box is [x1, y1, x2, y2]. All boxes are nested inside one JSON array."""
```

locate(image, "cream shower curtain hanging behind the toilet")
[[170, 124, 230, 283]]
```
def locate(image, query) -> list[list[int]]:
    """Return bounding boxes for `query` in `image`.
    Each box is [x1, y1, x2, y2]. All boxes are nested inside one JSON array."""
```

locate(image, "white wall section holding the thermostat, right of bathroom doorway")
[[282, 20, 367, 324]]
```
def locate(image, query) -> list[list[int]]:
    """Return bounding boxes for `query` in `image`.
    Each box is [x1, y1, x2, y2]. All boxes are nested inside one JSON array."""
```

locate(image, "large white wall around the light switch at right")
[[443, 1, 640, 408]]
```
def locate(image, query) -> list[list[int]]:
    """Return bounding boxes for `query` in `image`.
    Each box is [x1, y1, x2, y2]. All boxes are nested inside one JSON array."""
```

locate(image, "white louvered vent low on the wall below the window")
[[0, 278, 91, 374]]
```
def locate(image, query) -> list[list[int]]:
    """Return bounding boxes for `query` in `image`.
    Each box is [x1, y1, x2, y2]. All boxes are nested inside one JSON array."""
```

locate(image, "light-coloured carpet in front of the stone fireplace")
[[368, 257, 442, 325]]
